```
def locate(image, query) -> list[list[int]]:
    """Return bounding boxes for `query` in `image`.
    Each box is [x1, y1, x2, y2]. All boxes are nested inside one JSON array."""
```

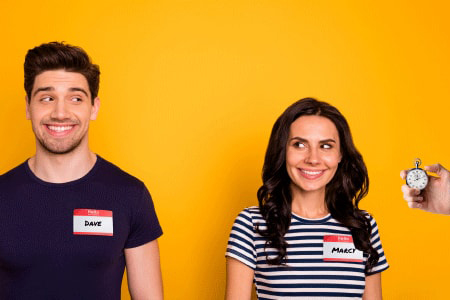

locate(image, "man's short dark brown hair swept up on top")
[[24, 42, 100, 104]]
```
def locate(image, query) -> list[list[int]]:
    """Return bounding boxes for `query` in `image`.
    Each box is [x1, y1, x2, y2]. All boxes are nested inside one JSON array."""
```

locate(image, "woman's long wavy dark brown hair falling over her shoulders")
[[257, 98, 379, 270]]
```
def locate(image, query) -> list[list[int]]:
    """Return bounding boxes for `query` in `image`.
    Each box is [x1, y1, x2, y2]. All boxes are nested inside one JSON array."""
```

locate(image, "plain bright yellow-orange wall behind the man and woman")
[[0, 0, 450, 299]]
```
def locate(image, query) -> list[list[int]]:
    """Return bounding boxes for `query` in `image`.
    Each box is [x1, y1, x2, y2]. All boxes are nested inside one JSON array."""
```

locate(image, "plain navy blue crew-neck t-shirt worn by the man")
[[0, 156, 162, 300]]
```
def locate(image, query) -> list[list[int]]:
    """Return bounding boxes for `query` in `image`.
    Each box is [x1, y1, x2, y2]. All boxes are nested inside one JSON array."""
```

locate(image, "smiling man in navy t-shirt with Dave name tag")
[[0, 42, 163, 300]]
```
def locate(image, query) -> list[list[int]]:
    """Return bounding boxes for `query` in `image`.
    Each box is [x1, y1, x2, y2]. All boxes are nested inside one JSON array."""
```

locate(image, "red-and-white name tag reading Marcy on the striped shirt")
[[323, 235, 363, 262]]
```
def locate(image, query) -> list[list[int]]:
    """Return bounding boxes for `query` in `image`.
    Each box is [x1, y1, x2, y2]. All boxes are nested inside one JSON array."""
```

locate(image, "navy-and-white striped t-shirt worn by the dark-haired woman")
[[226, 206, 389, 300]]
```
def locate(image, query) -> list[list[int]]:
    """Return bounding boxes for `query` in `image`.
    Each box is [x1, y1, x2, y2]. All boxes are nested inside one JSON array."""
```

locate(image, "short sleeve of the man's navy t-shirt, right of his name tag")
[[125, 185, 162, 248]]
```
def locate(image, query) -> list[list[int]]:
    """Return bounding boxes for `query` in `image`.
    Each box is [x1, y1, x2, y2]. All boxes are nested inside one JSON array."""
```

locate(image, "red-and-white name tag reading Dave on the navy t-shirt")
[[73, 209, 114, 236]]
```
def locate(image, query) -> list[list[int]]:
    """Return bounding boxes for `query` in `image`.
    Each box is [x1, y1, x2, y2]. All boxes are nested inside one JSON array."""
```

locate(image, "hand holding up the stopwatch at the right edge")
[[400, 164, 450, 215]]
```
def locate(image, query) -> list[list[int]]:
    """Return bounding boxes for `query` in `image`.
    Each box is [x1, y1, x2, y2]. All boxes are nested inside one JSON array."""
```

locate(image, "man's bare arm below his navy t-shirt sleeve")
[[125, 240, 163, 300]]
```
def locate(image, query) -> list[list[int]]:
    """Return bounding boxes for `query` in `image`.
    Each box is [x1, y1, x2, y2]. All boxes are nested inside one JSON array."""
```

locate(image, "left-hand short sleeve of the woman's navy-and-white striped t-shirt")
[[225, 209, 256, 269]]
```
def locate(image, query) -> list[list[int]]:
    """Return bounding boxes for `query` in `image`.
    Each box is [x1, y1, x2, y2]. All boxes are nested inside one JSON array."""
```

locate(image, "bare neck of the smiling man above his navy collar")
[[28, 150, 97, 183]]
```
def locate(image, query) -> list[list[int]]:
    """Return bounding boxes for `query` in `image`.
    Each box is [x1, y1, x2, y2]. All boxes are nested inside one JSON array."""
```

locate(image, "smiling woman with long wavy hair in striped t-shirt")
[[226, 98, 388, 300]]
